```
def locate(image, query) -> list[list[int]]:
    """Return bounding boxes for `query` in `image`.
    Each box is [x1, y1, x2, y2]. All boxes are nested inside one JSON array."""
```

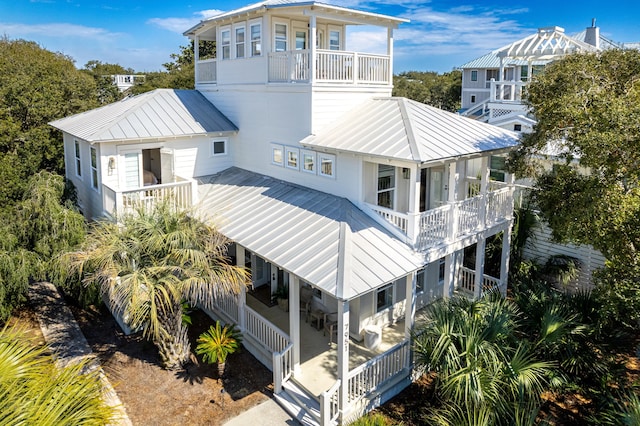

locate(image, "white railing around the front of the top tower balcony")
[[269, 50, 391, 85]]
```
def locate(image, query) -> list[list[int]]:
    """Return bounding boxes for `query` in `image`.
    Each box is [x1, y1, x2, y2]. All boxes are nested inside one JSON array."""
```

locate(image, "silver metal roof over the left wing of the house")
[[49, 89, 238, 142]]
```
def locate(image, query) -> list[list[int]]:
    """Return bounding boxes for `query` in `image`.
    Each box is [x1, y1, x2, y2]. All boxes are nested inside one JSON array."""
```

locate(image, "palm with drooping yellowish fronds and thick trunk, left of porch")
[[62, 204, 248, 369]]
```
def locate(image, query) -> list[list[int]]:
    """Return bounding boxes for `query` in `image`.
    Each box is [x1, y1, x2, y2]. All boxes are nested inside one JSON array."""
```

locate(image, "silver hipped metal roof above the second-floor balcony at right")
[[300, 98, 518, 163]]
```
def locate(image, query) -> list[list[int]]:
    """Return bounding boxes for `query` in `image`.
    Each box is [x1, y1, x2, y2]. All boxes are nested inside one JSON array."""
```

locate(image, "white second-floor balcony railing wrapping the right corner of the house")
[[367, 185, 513, 251]]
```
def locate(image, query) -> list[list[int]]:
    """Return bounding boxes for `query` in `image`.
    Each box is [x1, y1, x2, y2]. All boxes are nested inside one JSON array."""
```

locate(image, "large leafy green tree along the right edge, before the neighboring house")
[[510, 50, 640, 322]]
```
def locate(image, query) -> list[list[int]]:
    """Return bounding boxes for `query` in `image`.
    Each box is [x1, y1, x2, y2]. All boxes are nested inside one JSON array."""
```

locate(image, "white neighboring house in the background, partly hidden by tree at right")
[[459, 20, 640, 288]]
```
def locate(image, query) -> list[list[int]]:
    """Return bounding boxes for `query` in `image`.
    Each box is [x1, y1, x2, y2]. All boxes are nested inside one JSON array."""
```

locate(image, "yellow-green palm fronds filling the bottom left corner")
[[0, 327, 116, 426]]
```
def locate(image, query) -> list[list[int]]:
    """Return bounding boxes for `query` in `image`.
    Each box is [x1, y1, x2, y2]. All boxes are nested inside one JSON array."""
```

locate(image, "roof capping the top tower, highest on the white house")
[[183, 0, 409, 36]]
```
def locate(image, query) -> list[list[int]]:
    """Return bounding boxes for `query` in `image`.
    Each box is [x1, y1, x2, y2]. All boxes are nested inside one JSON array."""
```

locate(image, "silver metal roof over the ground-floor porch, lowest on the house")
[[199, 167, 422, 300]]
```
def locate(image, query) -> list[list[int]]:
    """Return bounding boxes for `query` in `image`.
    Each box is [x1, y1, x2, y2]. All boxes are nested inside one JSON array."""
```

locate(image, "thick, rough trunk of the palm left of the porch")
[[154, 304, 191, 370]]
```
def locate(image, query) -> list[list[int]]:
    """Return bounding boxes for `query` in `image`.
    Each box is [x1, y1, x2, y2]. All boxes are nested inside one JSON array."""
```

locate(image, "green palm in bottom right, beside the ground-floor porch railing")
[[414, 295, 551, 425]]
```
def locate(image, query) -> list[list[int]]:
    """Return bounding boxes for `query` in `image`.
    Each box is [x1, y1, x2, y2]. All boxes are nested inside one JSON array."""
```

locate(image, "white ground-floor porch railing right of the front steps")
[[347, 341, 411, 404]]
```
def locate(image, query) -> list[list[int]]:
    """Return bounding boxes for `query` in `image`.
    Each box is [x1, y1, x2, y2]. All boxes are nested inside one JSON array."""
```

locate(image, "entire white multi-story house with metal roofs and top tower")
[[52, 0, 517, 425]]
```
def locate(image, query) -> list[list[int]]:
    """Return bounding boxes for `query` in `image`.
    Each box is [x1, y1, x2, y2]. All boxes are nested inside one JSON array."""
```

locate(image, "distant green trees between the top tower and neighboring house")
[[393, 70, 462, 112]]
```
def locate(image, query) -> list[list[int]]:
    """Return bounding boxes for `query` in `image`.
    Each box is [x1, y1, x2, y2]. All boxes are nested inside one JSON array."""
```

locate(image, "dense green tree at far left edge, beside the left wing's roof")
[[0, 37, 98, 209]]
